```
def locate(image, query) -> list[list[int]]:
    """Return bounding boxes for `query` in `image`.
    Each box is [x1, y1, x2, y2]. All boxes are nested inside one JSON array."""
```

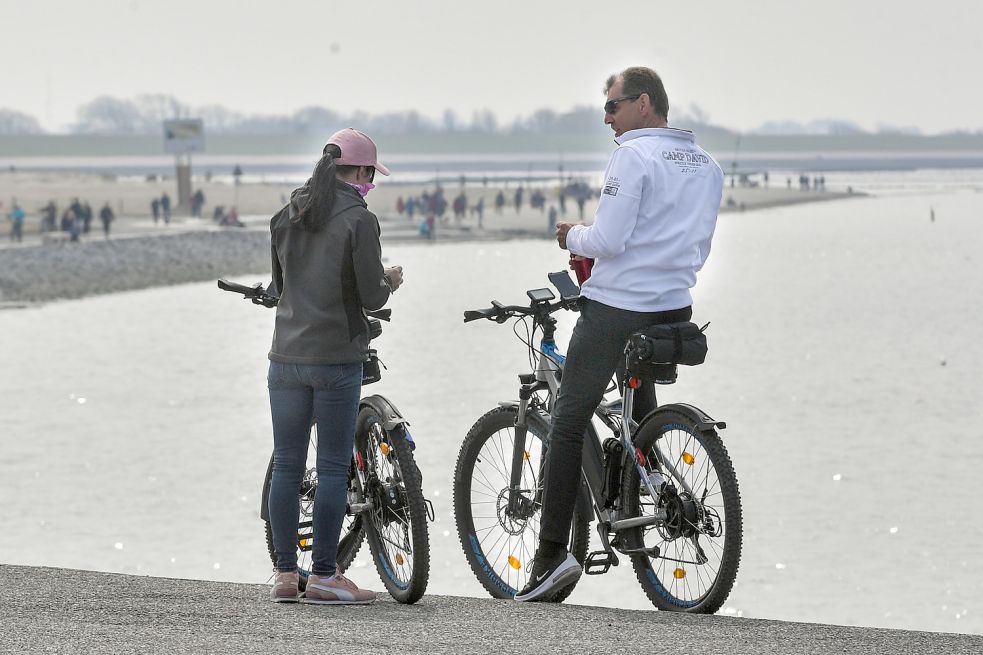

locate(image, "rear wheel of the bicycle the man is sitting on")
[[621, 410, 743, 614]]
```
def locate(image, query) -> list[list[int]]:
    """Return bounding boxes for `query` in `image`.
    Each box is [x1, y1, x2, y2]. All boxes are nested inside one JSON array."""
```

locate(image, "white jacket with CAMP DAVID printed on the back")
[[567, 127, 724, 312]]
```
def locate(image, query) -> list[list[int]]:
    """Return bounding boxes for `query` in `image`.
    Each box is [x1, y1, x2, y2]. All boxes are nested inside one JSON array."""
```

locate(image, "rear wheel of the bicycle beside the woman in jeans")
[[355, 406, 430, 604]]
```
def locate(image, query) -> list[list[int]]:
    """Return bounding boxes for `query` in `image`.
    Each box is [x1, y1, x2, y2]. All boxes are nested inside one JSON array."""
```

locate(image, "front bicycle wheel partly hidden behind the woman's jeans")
[[263, 425, 365, 591]]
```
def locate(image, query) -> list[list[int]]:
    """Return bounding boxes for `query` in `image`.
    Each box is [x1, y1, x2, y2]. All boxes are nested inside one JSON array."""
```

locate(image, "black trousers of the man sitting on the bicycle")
[[539, 299, 693, 545]]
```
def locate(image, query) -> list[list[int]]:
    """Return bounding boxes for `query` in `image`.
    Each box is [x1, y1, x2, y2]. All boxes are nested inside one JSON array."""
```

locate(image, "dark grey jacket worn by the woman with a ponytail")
[[269, 181, 389, 365]]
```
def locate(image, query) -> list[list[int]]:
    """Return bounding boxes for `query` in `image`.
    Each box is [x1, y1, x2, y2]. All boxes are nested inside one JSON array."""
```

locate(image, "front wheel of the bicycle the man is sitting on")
[[454, 406, 590, 603]]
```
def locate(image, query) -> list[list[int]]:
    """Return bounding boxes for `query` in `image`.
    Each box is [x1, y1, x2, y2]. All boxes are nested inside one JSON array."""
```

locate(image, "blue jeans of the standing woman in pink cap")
[[267, 362, 362, 576]]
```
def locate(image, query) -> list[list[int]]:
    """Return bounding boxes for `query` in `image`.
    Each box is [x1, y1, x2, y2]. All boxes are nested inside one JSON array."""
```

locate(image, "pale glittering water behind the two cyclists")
[[0, 178, 983, 633]]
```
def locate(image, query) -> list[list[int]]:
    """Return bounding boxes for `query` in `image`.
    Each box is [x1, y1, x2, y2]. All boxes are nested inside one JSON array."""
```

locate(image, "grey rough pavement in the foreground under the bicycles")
[[0, 565, 983, 655]]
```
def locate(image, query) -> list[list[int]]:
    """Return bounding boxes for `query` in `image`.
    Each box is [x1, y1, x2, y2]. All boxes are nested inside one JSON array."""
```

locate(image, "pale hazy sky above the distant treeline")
[[0, 0, 983, 133]]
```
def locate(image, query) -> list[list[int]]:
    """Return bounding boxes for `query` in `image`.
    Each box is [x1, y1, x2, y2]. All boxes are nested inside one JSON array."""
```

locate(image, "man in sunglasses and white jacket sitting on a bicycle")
[[515, 67, 723, 601]]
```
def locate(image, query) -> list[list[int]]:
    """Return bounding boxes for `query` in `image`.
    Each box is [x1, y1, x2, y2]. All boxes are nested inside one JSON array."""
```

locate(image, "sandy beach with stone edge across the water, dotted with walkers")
[[0, 171, 859, 307]]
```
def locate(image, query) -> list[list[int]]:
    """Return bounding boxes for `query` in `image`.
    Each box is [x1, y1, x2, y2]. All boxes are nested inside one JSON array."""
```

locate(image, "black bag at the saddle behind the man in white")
[[625, 321, 710, 384]]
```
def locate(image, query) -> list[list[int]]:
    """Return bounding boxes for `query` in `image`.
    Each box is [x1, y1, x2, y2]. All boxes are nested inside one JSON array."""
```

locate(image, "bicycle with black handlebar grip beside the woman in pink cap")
[[218, 280, 434, 603]]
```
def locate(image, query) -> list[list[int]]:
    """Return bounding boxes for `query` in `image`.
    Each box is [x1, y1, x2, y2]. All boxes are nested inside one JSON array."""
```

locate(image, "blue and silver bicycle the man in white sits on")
[[454, 273, 742, 613]]
